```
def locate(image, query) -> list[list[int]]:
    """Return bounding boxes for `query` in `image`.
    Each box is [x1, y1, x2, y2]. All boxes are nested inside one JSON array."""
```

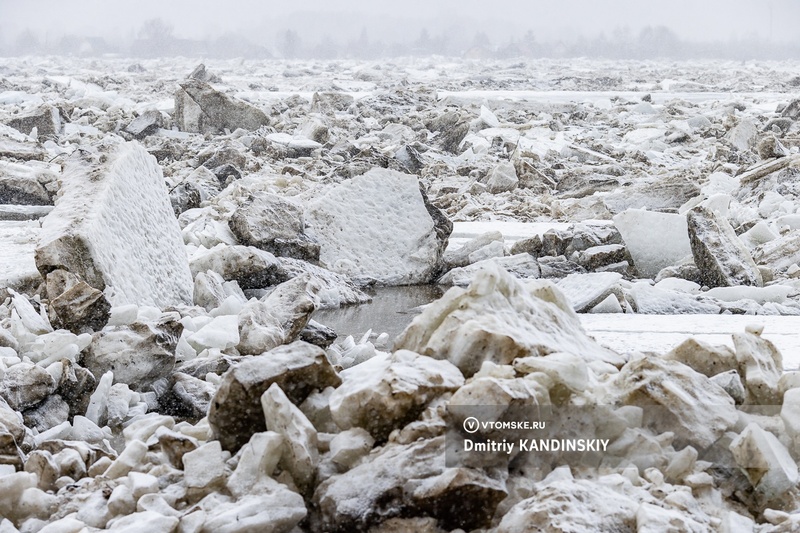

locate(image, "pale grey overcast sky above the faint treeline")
[[0, 0, 800, 47]]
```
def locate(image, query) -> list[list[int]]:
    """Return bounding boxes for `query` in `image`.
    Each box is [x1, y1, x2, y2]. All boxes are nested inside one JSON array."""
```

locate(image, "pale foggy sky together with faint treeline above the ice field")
[[0, 0, 800, 58]]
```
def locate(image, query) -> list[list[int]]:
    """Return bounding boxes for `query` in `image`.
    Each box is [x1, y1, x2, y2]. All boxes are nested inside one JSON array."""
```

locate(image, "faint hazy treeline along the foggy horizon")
[[0, 19, 800, 59]]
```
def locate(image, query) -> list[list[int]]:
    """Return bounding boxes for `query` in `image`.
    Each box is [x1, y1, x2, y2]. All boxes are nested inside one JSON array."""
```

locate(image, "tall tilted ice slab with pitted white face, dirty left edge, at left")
[[36, 142, 193, 308]]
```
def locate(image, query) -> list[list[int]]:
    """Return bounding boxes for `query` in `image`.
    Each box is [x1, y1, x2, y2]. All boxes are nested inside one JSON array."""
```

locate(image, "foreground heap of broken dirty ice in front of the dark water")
[[0, 258, 800, 531]]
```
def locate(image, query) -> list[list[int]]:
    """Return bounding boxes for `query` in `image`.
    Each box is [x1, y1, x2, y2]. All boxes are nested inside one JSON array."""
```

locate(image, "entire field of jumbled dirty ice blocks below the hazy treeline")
[[0, 58, 800, 533]]
